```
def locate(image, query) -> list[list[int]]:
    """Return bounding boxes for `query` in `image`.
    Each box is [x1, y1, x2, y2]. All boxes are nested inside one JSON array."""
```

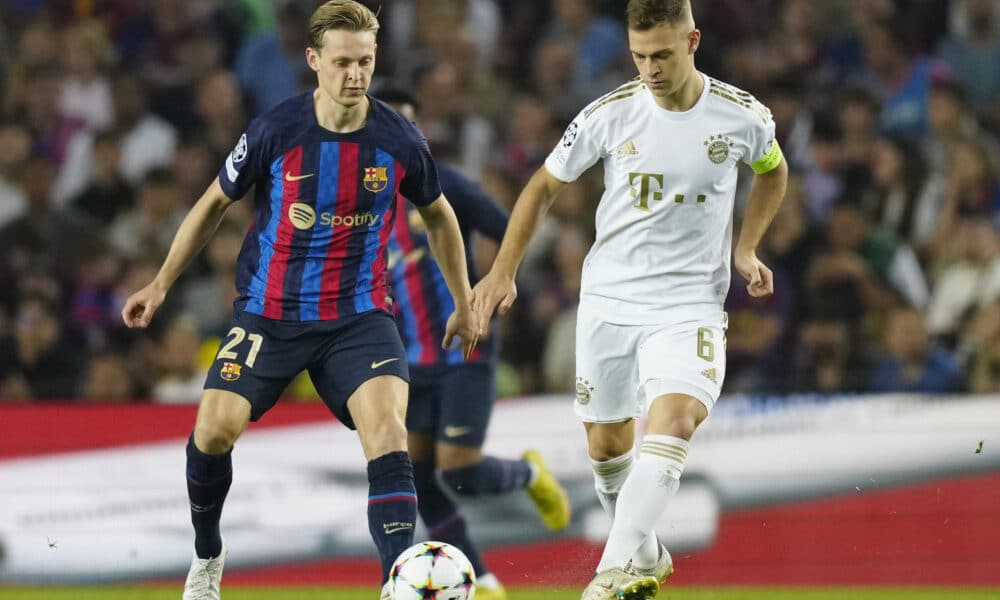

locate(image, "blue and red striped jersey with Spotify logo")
[[219, 92, 441, 321]]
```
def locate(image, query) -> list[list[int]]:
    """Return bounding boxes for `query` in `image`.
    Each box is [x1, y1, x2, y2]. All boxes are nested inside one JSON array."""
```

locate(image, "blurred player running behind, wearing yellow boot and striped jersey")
[[376, 89, 570, 600]]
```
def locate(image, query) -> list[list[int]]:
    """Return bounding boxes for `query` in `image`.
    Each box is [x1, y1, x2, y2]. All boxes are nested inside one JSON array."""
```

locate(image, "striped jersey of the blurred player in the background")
[[389, 165, 507, 366]]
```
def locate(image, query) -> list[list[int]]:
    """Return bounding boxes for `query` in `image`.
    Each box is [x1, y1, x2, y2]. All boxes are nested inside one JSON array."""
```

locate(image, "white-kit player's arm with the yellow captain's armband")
[[733, 140, 788, 298]]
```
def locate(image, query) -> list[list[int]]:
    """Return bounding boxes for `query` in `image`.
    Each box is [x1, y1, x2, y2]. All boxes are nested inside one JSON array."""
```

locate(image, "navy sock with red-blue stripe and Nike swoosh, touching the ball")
[[368, 452, 417, 583]]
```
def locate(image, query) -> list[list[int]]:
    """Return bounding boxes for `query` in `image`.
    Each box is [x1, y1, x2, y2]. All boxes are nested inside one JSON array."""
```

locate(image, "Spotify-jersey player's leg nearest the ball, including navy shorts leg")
[[309, 311, 417, 583]]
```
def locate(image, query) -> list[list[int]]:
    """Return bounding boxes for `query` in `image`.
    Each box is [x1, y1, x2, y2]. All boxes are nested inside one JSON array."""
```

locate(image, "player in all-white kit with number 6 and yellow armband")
[[473, 0, 788, 600]]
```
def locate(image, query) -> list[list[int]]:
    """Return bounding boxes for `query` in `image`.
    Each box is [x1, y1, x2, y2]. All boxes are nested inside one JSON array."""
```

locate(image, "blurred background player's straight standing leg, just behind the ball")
[[406, 366, 489, 583]]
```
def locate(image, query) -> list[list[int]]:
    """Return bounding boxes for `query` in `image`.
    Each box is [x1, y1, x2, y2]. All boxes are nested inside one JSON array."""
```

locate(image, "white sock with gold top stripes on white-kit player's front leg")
[[597, 434, 690, 572]]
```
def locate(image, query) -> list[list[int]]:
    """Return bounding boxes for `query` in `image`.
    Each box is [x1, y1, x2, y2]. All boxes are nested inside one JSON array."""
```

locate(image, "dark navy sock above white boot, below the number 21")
[[187, 433, 233, 558]]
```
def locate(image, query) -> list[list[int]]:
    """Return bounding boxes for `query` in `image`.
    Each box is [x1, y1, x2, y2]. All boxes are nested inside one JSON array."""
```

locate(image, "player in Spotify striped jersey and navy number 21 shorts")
[[122, 0, 478, 600]]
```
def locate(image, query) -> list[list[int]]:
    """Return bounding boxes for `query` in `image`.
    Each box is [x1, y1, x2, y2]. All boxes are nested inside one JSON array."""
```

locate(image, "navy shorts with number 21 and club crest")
[[205, 310, 409, 429]]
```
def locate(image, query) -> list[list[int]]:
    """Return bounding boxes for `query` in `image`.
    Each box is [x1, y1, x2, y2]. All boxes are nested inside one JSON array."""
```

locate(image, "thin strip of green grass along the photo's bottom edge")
[[0, 586, 1000, 600]]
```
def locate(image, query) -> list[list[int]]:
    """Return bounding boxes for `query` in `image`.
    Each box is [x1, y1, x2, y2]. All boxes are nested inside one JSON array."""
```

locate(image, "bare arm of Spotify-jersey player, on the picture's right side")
[[417, 194, 480, 358]]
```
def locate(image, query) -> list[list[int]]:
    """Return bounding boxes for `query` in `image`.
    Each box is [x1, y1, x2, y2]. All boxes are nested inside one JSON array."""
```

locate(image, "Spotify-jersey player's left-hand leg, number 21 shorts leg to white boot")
[[183, 313, 304, 600]]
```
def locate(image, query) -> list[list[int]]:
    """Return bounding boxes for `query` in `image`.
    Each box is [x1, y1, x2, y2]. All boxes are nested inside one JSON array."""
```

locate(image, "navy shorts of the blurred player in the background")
[[406, 362, 496, 448]]
